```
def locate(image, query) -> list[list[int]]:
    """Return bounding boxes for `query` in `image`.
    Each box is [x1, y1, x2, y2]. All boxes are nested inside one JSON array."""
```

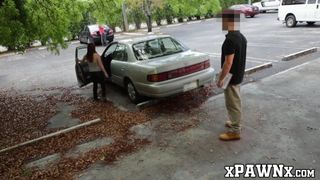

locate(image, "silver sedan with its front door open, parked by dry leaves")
[[76, 35, 214, 103]]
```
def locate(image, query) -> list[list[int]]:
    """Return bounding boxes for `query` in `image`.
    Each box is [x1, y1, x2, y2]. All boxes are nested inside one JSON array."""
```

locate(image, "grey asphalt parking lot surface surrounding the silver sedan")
[[0, 13, 320, 109]]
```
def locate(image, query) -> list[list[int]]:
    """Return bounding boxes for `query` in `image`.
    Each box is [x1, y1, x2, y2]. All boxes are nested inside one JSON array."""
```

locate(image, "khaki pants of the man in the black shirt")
[[224, 85, 242, 133]]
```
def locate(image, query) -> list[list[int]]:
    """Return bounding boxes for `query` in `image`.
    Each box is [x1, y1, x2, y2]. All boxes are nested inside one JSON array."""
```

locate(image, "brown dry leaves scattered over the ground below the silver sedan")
[[0, 86, 212, 179]]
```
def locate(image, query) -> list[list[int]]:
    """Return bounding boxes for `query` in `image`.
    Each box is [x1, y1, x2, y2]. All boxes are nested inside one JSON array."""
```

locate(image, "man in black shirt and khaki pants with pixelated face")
[[217, 10, 247, 141]]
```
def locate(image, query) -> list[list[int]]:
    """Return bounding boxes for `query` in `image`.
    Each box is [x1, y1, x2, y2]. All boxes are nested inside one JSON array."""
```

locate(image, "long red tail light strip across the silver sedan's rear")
[[147, 60, 210, 82]]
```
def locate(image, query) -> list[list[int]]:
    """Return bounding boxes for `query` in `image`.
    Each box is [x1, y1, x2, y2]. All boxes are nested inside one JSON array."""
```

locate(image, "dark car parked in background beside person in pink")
[[79, 24, 114, 44]]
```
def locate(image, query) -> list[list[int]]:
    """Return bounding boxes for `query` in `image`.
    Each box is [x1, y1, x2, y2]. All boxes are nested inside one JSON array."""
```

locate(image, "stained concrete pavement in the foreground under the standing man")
[[77, 59, 320, 180]]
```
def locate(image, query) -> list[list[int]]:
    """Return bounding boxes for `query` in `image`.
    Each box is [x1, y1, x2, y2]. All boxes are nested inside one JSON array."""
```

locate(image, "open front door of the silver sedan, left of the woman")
[[75, 46, 92, 87]]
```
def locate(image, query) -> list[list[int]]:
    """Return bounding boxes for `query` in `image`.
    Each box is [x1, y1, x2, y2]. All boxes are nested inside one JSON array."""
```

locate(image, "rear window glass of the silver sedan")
[[133, 37, 186, 60]]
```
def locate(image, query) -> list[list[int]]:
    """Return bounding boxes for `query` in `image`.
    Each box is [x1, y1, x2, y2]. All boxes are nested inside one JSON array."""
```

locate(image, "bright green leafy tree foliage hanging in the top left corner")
[[0, 0, 86, 53]]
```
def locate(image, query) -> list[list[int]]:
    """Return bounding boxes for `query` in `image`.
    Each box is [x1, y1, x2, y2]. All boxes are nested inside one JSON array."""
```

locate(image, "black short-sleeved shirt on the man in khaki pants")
[[221, 31, 247, 85]]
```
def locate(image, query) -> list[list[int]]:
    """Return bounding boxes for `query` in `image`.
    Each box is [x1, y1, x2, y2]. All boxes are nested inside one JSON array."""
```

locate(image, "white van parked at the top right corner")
[[278, 0, 320, 27]]
